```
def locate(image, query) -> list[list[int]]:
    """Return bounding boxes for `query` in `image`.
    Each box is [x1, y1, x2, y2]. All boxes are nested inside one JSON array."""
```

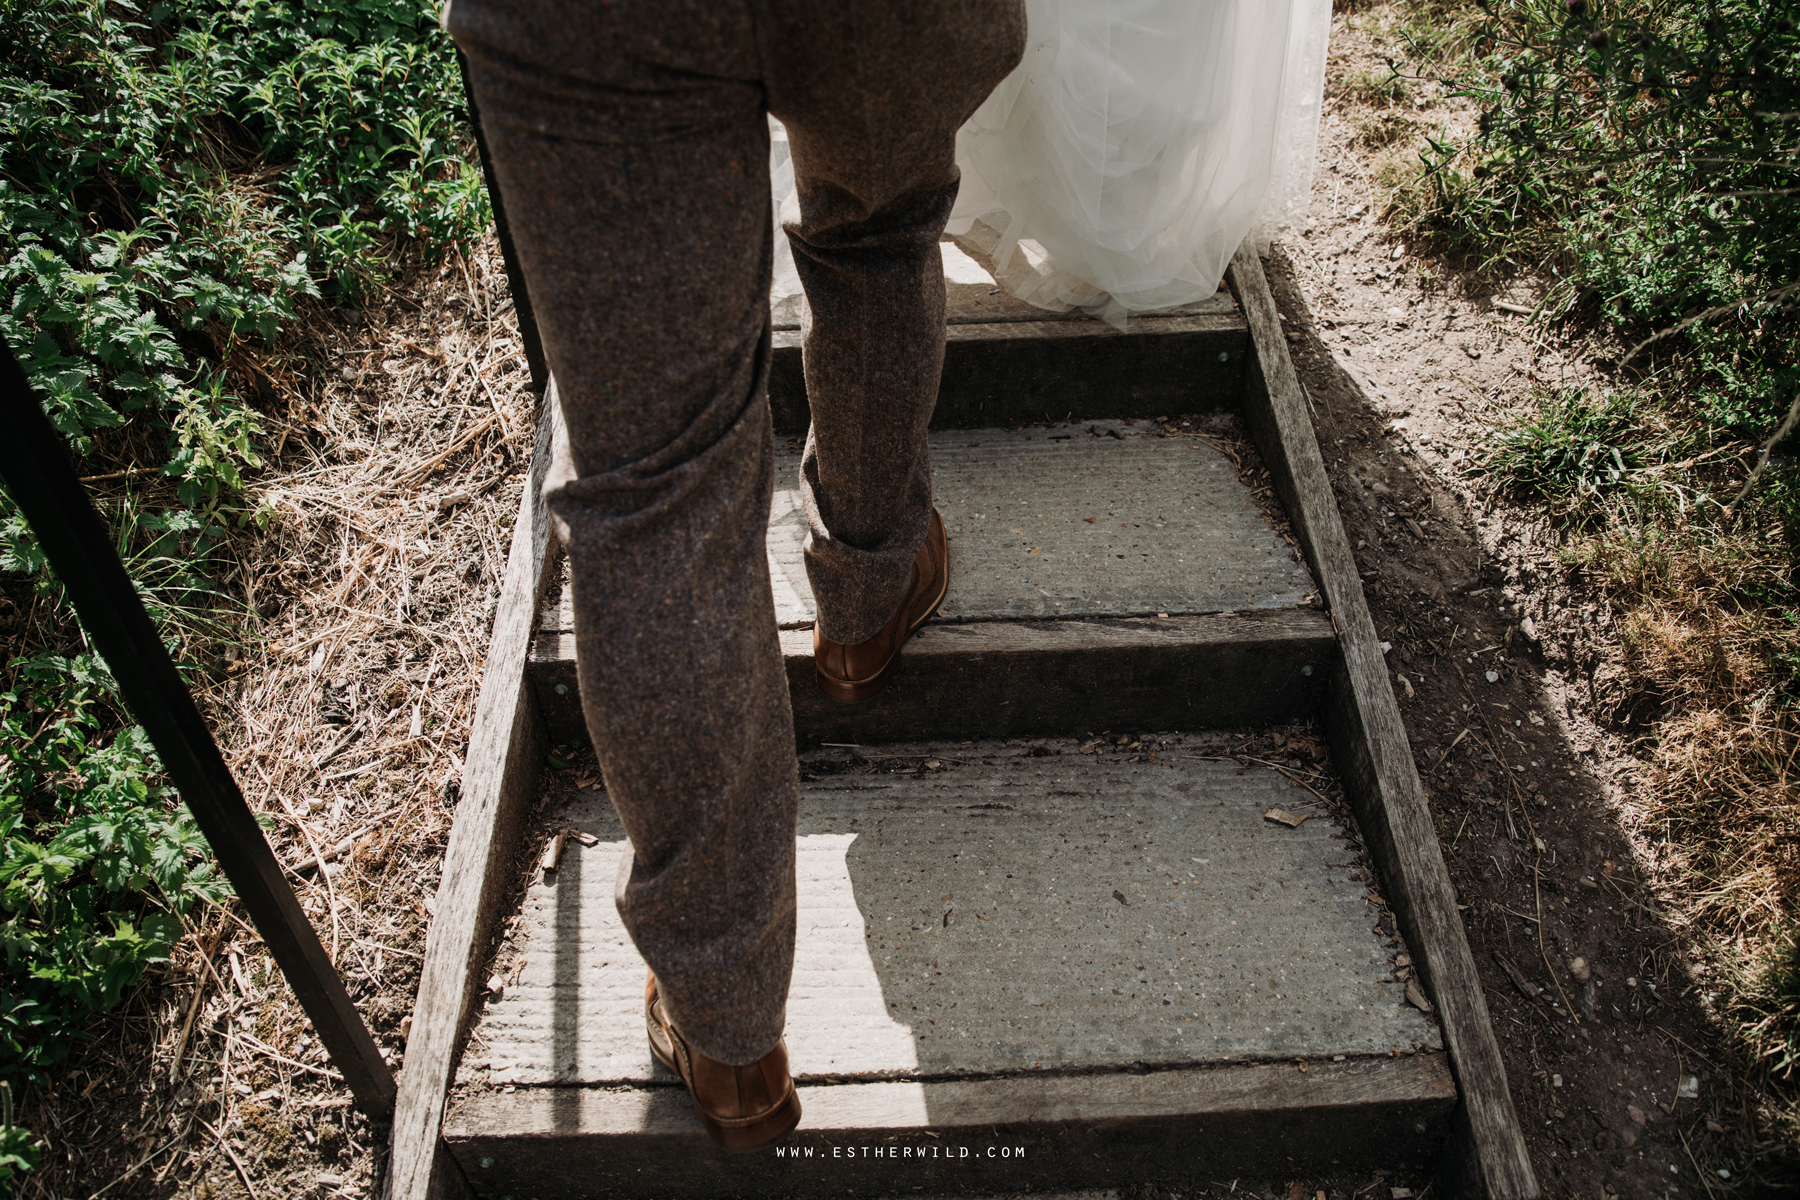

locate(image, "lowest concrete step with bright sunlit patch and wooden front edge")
[[445, 734, 1454, 1200]]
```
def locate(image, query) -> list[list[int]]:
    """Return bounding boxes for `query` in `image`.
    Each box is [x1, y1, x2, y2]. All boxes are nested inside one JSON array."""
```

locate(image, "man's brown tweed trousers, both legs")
[[448, 0, 1024, 1065]]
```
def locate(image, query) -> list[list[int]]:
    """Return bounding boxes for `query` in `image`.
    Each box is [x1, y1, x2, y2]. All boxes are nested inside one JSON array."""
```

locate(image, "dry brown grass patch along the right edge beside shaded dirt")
[[1586, 529, 1800, 1139]]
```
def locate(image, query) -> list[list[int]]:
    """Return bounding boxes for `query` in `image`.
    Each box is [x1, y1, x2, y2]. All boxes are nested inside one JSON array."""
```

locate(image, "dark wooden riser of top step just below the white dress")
[[769, 313, 1249, 437]]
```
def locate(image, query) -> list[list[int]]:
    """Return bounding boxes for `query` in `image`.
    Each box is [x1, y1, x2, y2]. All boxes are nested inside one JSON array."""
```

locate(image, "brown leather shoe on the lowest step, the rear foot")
[[644, 972, 799, 1150]]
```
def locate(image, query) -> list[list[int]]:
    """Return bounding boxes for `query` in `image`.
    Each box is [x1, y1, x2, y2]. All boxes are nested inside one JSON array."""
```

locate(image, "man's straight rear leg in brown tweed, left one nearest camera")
[[450, 0, 797, 1065]]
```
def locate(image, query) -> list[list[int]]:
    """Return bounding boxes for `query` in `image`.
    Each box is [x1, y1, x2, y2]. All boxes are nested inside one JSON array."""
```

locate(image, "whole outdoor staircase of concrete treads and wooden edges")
[[396, 241, 1535, 1200]]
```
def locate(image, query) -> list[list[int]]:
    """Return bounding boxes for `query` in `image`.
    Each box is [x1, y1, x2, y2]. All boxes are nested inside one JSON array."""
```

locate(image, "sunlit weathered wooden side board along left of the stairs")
[[389, 390, 567, 1200]]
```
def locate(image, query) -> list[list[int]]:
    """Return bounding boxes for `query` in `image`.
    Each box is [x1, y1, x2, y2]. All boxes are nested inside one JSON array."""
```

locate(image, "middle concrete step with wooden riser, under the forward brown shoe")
[[531, 421, 1337, 745]]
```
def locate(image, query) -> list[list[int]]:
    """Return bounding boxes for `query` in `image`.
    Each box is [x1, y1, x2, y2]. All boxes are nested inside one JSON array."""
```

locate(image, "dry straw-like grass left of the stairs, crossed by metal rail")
[[20, 232, 535, 1198]]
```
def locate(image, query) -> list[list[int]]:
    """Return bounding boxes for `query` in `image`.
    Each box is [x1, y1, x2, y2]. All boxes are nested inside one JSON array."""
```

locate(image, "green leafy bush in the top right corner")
[[1408, 0, 1800, 467]]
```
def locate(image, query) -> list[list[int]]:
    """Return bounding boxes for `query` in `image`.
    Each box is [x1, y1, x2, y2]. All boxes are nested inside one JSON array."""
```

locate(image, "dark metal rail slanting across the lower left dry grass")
[[0, 342, 394, 1119]]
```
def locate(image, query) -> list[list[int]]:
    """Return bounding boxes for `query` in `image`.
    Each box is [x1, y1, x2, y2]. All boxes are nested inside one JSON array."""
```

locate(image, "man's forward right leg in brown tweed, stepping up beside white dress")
[[763, 0, 1024, 642]]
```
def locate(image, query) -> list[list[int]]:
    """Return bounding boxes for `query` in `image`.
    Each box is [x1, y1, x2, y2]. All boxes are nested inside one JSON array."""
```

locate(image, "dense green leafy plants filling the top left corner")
[[0, 0, 488, 504]]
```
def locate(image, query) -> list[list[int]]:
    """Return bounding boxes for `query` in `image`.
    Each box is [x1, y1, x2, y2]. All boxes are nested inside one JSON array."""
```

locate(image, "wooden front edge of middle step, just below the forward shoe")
[[529, 608, 1337, 747]]
